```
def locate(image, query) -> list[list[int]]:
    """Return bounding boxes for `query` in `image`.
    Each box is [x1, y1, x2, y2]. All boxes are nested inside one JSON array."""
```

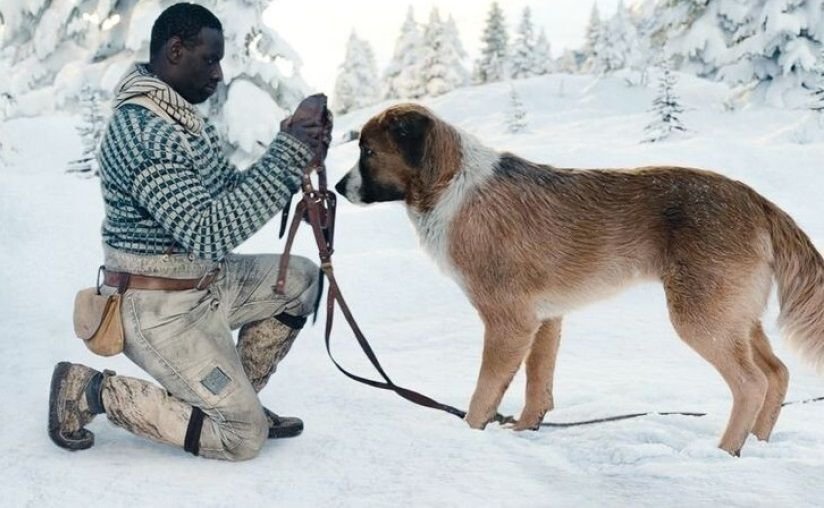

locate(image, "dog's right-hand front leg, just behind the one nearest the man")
[[514, 318, 561, 430]]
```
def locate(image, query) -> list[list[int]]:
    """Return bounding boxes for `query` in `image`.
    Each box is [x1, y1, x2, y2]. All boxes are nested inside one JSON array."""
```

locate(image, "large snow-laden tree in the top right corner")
[[719, 0, 824, 106]]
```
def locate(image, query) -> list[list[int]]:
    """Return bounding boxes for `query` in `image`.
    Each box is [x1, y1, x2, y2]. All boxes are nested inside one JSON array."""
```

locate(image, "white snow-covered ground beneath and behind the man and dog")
[[0, 75, 824, 507]]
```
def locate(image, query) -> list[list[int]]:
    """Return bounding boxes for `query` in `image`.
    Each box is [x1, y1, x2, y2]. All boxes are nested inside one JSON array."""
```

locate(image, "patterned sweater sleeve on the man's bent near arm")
[[130, 117, 312, 260]]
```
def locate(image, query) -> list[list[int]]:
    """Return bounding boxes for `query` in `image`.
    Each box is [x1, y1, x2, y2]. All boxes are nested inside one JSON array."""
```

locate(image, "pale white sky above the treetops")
[[264, 0, 618, 96]]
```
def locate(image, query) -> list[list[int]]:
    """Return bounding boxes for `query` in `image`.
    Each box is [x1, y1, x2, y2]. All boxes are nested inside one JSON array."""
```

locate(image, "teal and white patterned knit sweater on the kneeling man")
[[98, 104, 312, 261]]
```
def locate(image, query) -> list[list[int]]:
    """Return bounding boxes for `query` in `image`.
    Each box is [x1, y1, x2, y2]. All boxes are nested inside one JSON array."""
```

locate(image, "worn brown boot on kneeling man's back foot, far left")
[[49, 362, 114, 450]]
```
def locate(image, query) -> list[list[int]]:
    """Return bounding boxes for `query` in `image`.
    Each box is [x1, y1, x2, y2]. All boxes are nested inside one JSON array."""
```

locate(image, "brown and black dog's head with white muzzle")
[[335, 104, 464, 208]]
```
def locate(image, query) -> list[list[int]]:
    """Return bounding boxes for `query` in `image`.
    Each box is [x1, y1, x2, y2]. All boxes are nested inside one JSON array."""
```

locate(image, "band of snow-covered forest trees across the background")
[[0, 0, 824, 157]]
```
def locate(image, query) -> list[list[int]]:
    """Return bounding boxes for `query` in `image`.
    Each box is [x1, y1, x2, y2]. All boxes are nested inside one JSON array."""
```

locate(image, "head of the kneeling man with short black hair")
[[149, 3, 223, 104]]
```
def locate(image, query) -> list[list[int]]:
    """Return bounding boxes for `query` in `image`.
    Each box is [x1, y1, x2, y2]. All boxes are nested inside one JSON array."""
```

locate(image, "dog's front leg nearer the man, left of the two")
[[466, 313, 538, 429]]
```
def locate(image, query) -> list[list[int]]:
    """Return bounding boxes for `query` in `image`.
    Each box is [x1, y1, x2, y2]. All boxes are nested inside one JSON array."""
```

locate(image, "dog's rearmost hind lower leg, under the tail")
[[750, 322, 790, 441]]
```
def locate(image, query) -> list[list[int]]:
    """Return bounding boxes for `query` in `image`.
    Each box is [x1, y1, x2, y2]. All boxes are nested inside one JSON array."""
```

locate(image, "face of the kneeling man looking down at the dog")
[[172, 28, 223, 104]]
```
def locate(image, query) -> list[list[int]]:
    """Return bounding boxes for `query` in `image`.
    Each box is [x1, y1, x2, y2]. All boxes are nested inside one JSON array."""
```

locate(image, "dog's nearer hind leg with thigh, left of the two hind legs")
[[664, 274, 768, 456]]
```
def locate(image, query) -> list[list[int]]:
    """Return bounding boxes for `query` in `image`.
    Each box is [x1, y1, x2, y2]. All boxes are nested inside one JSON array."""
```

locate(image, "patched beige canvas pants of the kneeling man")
[[95, 247, 318, 460]]
